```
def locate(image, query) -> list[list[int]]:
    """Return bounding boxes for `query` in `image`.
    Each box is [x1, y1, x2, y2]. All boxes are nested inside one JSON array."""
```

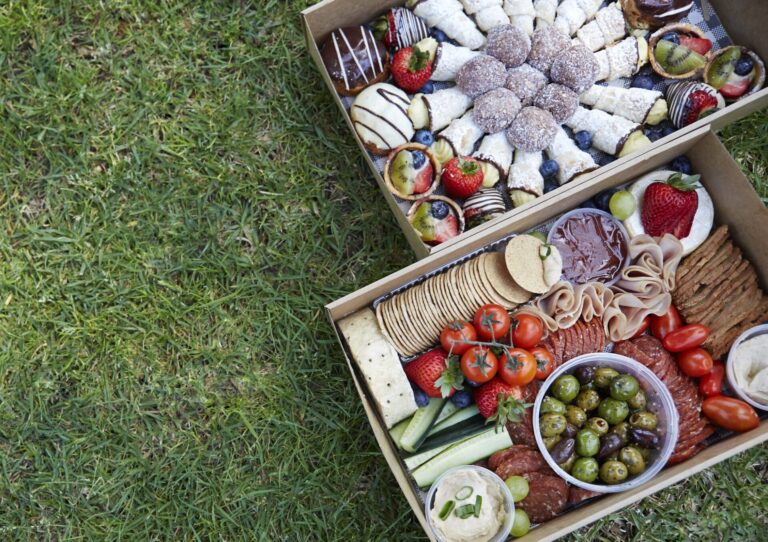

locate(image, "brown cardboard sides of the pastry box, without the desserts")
[[301, 0, 768, 258]]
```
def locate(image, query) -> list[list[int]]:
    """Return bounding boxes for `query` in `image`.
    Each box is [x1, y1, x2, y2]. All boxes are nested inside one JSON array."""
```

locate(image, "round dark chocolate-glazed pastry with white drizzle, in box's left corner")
[[320, 26, 389, 96]]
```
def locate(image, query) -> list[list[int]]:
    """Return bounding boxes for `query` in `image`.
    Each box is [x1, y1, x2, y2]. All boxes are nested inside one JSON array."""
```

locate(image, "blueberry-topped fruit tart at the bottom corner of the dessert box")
[[408, 196, 464, 245]]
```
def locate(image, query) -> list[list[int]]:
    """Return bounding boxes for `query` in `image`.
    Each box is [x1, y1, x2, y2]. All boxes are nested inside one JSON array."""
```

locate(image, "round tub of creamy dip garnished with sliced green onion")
[[429, 469, 506, 542]]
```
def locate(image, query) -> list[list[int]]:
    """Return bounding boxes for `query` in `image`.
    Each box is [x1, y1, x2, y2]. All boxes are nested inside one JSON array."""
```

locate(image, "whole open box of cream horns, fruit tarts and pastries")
[[302, 0, 768, 258]]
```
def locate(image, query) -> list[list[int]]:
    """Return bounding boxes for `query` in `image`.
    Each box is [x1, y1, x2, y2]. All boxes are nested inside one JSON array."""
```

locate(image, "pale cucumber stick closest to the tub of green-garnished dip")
[[413, 427, 512, 487]]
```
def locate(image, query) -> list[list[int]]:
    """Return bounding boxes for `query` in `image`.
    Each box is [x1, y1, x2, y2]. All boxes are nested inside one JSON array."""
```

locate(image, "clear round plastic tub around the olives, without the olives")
[[533, 352, 678, 493]]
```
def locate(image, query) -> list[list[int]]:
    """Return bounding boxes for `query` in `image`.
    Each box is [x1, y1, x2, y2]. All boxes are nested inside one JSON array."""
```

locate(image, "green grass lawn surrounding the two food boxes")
[[0, 0, 768, 541]]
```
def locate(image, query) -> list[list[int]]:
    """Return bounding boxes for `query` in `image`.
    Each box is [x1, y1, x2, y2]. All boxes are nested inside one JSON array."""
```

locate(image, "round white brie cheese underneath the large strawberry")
[[624, 169, 715, 256]]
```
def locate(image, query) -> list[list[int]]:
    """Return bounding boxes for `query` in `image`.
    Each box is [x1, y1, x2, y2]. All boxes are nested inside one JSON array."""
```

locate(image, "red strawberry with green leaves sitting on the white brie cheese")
[[640, 173, 700, 239]]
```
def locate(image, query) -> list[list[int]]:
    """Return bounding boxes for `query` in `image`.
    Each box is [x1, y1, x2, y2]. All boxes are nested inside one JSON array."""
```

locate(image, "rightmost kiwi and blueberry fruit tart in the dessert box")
[[704, 45, 765, 102]]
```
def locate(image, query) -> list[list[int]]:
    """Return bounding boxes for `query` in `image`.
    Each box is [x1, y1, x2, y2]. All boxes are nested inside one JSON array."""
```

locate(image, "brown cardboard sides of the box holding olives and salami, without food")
[[326, 127, 768, 541]]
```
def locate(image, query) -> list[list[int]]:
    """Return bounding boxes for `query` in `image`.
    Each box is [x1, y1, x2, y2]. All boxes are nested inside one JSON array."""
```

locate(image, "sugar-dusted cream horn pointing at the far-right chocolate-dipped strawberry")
[[579, 85, 667, 125]]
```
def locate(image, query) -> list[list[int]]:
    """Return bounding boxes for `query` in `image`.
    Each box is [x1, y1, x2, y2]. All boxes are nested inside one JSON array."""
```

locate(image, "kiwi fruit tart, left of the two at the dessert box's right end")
[[648, 23, 712, 79]]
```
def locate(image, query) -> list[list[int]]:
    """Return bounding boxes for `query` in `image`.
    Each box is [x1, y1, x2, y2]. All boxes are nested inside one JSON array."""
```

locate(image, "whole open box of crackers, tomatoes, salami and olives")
[[326, 126, 768, 542]]
